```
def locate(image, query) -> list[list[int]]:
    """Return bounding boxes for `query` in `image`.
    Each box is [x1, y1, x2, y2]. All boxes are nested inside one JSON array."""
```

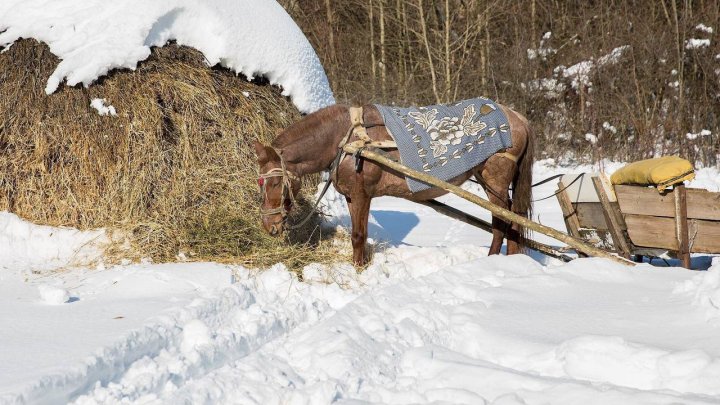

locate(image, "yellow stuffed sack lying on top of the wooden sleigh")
[[610, 156, 695, 191]]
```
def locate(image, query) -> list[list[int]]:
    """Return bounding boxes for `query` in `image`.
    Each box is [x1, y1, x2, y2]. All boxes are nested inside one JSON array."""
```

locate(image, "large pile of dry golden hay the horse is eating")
[[0, 40, 344, 266]]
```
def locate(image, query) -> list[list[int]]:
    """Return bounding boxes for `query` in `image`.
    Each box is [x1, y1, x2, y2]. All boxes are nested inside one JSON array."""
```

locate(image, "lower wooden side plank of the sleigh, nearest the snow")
[[625, 214, 720, 253]]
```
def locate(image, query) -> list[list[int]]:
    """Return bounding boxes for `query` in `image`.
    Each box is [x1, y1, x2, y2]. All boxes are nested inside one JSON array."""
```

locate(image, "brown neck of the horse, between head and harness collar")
[[273, 105, 350, 176]]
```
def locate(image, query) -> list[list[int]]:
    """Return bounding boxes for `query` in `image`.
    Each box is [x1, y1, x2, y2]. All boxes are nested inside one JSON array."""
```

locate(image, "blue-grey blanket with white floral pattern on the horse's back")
[[375, 97, 512, 193]]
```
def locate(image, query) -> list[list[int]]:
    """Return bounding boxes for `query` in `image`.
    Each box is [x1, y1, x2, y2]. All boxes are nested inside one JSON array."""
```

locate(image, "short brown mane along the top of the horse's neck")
[[271, 104, 348, 148]]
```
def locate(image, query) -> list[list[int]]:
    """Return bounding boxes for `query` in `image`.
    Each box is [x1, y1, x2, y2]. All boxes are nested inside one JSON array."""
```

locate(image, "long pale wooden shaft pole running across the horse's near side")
[[344, 144, 635, 266]]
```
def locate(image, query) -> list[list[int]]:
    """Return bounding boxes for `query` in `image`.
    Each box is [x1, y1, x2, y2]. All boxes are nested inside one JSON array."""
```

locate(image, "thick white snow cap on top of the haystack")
[[0, 0, 335, 113]]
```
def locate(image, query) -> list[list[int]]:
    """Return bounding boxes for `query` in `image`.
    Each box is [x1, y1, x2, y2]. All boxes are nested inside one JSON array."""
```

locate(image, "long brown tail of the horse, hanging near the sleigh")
[[512, 121, 535, 248]]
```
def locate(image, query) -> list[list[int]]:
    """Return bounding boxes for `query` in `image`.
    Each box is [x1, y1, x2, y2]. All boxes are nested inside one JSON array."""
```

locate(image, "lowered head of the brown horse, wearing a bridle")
[[255, 141, 300, 236]]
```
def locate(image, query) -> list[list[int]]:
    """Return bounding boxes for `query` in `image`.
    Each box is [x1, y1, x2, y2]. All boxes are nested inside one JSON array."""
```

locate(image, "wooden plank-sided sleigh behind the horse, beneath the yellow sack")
[[557, 174, 720, 268]]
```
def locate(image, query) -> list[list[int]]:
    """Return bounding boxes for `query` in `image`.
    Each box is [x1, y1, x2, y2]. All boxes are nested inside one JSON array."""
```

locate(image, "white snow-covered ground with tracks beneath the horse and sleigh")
[[0, 162, 720, 404]]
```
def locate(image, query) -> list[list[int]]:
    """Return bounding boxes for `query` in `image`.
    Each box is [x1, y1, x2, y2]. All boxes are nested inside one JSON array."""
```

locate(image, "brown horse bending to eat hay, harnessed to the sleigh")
[[255, 105, 534, 265]]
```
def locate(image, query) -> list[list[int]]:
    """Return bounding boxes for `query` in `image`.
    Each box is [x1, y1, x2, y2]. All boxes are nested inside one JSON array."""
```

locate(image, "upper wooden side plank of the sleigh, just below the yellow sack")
[[615, 185, 720, 221]]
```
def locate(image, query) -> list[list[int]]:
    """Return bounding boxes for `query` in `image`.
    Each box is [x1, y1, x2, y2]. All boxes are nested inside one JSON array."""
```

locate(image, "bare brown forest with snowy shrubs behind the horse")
[[280, 0, 720, 167]]
